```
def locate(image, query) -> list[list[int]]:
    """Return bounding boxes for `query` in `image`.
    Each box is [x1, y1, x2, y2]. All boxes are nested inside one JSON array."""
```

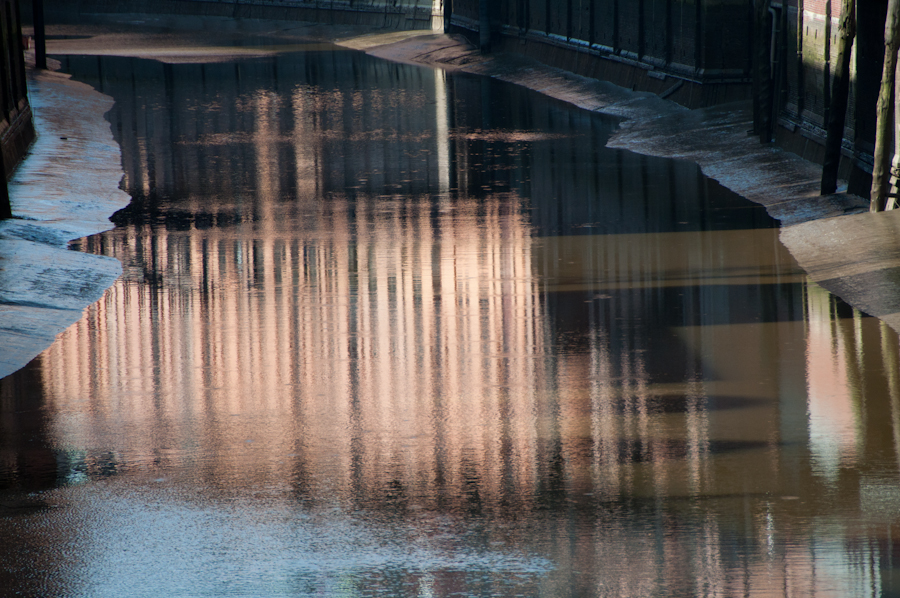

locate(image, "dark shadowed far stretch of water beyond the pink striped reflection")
[[61, 51, 775, 236]]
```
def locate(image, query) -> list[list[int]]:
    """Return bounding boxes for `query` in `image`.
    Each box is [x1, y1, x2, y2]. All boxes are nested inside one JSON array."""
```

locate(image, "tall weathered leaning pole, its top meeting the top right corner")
[[869, 0, 900, 212]]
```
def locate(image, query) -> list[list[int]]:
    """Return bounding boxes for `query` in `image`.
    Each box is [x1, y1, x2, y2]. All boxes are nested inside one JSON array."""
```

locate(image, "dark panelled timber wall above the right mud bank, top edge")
[[450, 0, 754, 107]]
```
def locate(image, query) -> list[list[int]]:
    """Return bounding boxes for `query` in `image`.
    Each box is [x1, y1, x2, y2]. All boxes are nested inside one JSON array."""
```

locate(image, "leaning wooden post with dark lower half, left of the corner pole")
[[821, 0, 856, 195]]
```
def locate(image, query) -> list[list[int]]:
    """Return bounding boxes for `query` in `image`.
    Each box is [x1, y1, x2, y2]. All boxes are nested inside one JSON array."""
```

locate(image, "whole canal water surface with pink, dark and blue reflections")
[[0, 39, 900, 597]]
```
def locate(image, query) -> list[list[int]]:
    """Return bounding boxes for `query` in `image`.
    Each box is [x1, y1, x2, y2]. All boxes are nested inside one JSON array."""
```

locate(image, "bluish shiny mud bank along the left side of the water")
[[0, 71, 130, 378]]
